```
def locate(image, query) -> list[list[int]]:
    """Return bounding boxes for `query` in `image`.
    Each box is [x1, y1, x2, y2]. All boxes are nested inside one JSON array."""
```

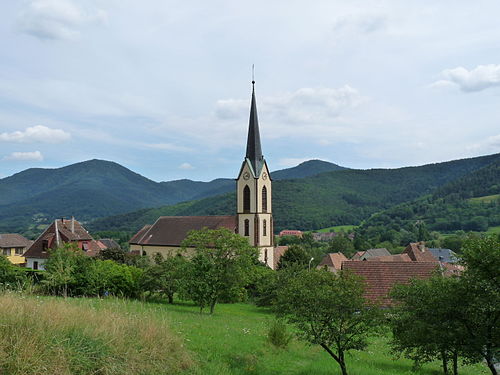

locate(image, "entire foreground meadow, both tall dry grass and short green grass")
[[0, 294, 488, 375]]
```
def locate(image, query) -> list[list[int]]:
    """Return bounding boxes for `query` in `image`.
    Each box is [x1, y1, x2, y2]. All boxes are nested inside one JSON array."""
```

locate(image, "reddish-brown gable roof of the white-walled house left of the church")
[[24, 219, 94, 259]]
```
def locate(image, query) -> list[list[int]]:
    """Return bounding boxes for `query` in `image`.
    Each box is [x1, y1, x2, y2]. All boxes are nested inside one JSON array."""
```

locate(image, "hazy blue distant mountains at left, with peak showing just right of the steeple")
[[0, 156, 339, 232]]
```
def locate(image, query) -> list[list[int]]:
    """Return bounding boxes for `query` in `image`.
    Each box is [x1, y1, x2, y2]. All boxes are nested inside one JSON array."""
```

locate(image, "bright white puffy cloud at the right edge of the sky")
[[432, 64, 500, 92]]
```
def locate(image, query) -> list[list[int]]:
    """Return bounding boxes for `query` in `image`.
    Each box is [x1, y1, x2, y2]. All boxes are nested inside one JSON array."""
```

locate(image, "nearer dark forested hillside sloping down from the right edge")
[[359, 159, 500, 244]]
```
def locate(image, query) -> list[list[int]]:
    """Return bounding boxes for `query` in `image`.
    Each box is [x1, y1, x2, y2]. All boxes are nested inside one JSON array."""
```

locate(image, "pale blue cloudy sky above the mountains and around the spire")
[[0, 0, 500, 181]]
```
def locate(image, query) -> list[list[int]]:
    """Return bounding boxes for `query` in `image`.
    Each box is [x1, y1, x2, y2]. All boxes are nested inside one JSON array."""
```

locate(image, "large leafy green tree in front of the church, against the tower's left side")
[[183, 228, 258, 314]]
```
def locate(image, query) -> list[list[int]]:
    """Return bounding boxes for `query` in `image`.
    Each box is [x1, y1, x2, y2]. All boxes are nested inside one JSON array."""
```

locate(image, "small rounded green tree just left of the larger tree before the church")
[[141, 254, 186, 304]]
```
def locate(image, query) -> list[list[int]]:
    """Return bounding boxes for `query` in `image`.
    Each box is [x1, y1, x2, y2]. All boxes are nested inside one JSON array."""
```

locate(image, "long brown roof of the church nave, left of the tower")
[[129, 216, 238, 246]]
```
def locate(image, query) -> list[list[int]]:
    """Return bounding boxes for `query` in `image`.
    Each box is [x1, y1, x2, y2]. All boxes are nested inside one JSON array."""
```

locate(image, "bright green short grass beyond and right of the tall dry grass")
[[60, 299, 488, 375]]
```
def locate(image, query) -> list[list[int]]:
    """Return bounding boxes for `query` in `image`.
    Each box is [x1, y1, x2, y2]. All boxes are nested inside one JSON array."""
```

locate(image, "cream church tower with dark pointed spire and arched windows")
[[236, 81, 274, 268]]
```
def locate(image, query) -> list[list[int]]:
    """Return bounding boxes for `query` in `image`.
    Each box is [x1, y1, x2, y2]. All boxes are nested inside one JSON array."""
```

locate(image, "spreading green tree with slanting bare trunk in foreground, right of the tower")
[[276, 270, 380, 375]]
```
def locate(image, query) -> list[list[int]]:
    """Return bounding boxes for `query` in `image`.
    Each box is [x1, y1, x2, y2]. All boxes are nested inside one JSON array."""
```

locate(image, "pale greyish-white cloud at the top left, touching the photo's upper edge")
[[17, 0, 106, 39]]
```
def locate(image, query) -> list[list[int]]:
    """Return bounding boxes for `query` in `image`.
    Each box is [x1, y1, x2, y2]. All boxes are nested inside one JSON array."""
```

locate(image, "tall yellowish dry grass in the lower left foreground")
[[0, 294, 193, 375]]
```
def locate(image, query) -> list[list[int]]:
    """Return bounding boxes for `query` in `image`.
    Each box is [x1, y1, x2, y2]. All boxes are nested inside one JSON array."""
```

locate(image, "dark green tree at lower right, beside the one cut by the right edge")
[[390, 275, 477, 375]]
